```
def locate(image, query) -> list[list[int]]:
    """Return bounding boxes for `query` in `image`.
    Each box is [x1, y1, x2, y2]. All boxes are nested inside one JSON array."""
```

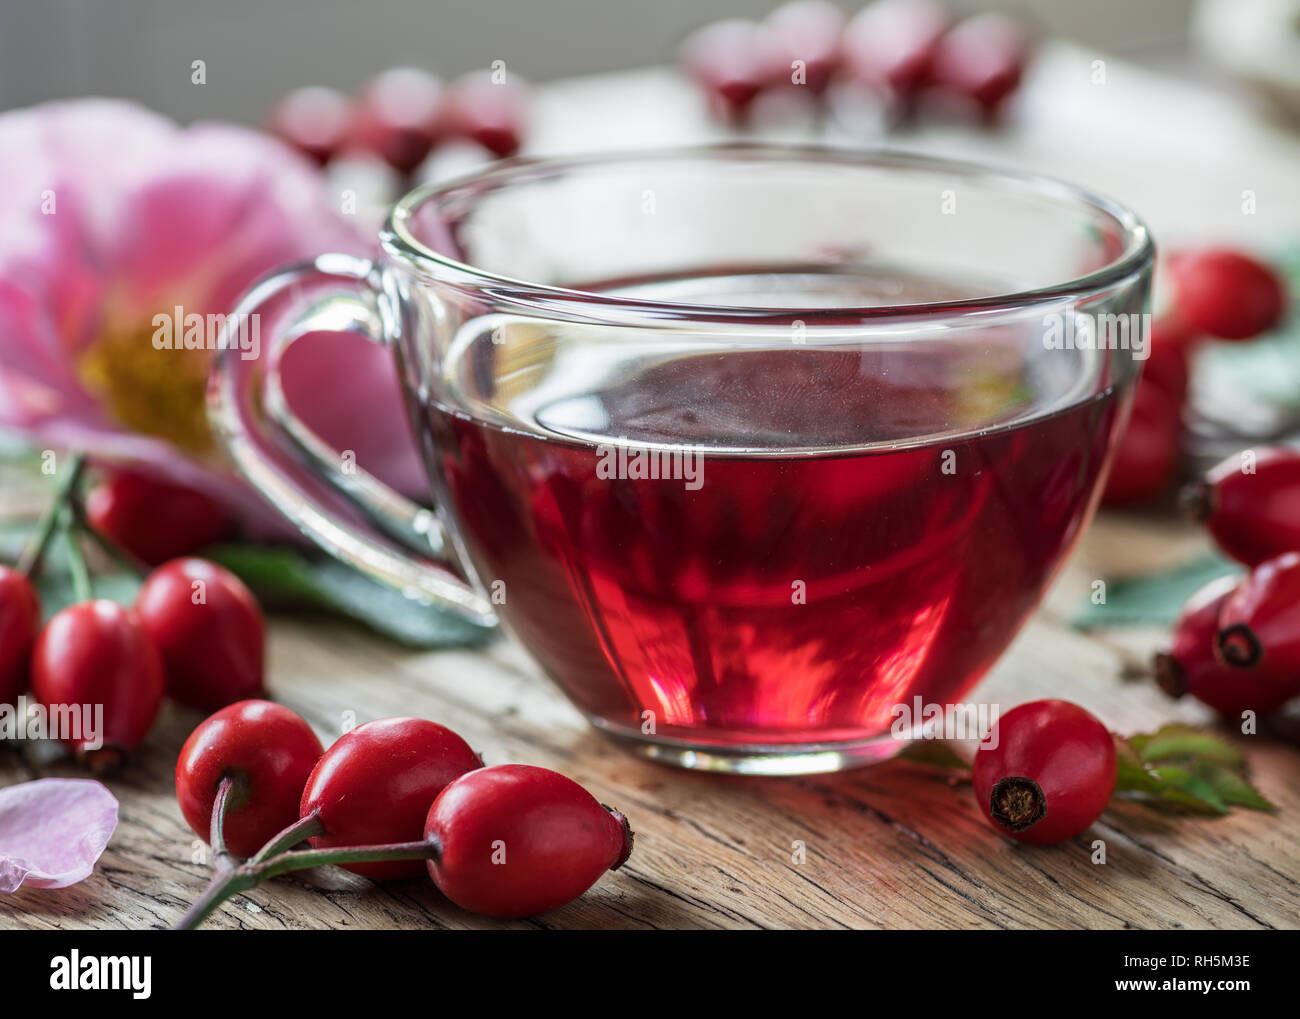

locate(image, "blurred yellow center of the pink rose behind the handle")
[[78, 315, 212, 456]]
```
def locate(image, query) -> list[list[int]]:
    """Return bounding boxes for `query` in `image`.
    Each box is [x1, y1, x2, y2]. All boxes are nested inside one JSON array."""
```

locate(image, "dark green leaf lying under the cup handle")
[[203, 545, 493, 647]]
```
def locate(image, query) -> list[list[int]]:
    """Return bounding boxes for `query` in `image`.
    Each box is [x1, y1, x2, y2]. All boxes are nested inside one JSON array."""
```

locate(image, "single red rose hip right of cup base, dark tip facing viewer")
[[971, 701, 1117, 846]]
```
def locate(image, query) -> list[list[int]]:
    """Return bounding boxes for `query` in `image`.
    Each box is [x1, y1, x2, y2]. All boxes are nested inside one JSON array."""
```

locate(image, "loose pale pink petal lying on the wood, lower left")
[[0, 779, 117, 892]]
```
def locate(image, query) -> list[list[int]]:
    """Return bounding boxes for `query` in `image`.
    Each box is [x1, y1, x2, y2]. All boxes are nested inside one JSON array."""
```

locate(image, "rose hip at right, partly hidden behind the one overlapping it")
[[1154, 577, 1300, 717]]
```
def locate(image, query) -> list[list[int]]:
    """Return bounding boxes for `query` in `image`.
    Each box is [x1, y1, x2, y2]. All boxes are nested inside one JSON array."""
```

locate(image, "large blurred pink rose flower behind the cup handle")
[[0, 99, 421, 532]]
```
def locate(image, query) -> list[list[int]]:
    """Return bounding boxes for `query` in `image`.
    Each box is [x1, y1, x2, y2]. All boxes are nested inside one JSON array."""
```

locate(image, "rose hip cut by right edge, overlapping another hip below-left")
[[1216, 552, 1300, 684]]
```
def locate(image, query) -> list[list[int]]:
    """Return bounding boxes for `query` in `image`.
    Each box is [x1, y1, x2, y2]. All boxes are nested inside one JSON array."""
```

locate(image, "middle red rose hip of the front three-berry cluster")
[[299, 719, 482, 879]]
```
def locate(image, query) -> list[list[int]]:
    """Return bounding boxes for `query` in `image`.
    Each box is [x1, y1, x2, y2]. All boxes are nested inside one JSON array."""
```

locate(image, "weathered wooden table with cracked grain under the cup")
[[0, 48, 1300, 928]]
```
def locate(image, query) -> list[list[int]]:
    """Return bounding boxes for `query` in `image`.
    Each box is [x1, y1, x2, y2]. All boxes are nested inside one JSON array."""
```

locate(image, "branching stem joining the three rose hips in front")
[[172, 805, 442, 931]]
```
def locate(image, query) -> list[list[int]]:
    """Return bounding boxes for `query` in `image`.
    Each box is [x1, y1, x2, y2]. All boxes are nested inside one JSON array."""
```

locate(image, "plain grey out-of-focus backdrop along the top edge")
[[0, 0, 1211, 122]]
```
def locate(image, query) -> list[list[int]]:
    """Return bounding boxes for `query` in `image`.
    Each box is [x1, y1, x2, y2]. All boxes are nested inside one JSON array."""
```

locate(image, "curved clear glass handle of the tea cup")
[[207, 255, 497, 626]]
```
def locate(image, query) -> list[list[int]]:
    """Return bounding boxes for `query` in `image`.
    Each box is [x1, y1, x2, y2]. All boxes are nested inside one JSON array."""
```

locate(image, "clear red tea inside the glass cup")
[[425, 272, 1117, 749]]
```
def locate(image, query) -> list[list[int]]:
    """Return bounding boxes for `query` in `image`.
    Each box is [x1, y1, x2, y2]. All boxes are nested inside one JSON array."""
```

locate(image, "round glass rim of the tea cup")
[[380, 142, 1154, 326]]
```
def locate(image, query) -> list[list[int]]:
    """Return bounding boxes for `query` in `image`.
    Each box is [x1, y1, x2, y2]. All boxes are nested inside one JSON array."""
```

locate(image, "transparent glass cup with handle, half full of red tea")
[[209, 146, 1152, 773]]
